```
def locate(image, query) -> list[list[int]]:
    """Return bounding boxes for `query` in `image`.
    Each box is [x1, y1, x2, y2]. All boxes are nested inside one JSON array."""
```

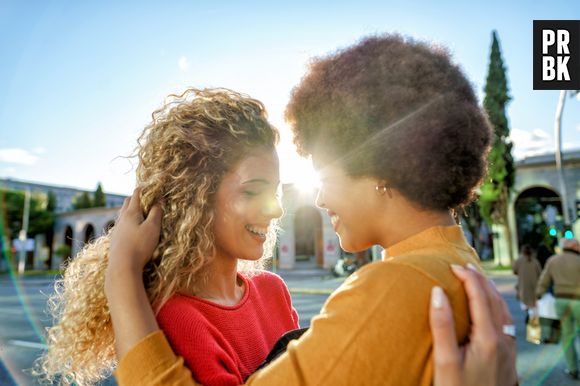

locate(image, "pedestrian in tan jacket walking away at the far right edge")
[[537, 239, 580, 379]]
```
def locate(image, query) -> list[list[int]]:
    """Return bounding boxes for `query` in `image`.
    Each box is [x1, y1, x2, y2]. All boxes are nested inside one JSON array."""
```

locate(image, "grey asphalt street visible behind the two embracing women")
[[0, 270, 578, 385]]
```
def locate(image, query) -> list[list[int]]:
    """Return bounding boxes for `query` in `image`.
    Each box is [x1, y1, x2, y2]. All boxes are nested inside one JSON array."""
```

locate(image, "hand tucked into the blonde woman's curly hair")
[[108, 188, 163, 274]]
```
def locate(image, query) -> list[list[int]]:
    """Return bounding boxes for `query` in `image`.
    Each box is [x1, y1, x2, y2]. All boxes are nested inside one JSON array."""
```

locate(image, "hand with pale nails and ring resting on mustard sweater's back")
[[430, 267, 518, 386]]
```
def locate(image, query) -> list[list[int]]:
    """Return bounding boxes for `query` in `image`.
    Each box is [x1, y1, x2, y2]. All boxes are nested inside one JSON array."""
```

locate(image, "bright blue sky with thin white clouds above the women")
[[0, 0, 580, 193]]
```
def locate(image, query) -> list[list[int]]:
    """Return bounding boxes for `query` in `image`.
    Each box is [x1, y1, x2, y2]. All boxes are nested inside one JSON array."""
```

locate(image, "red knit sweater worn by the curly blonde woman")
[[157, 271, 299, 385]]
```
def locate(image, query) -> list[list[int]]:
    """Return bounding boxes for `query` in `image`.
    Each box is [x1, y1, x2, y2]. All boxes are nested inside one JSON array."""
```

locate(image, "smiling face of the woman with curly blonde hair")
[[213, 150, 283, 260]]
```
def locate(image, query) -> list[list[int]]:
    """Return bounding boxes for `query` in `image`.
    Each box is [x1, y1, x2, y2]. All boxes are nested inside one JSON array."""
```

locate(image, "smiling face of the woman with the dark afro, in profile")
[[316, 161, 381, 252]]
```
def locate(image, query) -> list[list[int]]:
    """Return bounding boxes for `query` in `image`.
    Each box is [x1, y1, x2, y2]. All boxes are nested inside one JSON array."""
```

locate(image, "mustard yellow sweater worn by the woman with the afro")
[[115, 226, 479, 386]]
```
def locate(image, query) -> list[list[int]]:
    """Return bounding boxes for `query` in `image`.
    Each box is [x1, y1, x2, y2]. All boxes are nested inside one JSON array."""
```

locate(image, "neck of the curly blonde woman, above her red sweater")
[[196, 256, 244, 306]]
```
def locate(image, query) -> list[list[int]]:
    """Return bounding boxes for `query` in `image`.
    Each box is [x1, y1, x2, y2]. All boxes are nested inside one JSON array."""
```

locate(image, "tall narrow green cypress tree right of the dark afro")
[[479, 31, 515, 261]]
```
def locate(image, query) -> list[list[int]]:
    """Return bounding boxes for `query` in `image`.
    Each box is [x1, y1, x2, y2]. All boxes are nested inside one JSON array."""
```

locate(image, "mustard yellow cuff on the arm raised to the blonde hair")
[[115, 330, 177, 386]]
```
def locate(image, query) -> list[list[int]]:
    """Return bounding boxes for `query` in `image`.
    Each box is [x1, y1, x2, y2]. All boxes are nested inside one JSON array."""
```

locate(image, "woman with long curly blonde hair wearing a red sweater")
[[38, 89, 298, 385]]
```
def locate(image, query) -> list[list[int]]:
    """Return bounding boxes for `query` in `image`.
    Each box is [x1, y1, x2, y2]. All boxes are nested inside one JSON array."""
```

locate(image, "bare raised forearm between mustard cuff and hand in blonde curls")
[[105, 267, 159, 359]]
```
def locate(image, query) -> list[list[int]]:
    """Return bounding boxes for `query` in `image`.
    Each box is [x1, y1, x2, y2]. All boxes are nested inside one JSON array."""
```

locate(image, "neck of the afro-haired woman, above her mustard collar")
[[378, 196, 456, 249]]
